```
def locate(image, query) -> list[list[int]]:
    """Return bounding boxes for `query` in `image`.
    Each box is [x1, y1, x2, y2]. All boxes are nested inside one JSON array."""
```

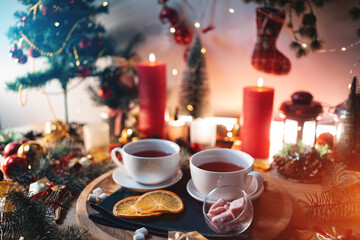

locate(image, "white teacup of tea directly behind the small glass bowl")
[[190, 148, 263, 196]]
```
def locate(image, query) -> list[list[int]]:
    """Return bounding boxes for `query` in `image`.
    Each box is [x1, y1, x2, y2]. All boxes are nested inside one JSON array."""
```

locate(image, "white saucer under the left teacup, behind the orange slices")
[[113, 167, 183, 192]]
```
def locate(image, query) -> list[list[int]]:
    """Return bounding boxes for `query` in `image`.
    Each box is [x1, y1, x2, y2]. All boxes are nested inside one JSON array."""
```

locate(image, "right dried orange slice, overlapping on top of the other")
[[135, 190, 184, 213]]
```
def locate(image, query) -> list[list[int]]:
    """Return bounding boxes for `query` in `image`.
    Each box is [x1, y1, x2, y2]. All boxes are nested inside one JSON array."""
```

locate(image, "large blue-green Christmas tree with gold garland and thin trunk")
[[7, 0, 112, 122]]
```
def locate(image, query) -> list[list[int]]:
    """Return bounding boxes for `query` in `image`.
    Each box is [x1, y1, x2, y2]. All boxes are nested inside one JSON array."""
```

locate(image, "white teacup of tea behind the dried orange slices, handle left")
[[111, 139, 180, 185]]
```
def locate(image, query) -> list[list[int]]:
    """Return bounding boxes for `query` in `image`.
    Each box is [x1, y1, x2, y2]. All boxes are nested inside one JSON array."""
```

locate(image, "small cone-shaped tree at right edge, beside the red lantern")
[[337, 77, 360, 170]]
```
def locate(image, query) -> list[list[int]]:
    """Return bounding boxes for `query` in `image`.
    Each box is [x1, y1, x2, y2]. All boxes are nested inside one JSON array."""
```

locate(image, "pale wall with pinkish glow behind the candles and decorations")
[[0, 0, 360, 128]]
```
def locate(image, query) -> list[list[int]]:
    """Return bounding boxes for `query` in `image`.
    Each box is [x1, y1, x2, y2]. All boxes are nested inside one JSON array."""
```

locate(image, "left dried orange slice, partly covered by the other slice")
[[113, 196, 162, 218]]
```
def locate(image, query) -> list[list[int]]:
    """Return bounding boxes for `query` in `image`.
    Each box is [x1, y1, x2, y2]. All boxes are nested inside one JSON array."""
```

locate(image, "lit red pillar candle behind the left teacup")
[[137, 54, 166, 138]]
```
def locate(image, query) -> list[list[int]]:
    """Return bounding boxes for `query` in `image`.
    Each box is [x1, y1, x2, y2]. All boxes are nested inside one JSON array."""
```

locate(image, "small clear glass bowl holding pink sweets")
[[202, 185, 254, 235]]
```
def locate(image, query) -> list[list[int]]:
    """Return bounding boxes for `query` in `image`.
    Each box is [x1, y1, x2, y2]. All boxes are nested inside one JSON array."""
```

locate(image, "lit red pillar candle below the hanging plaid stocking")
[[241, 78, 274, 158]]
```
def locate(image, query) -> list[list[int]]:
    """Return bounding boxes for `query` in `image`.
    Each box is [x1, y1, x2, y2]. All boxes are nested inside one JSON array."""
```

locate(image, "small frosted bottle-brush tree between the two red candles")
[[179, 35, 209, 118]]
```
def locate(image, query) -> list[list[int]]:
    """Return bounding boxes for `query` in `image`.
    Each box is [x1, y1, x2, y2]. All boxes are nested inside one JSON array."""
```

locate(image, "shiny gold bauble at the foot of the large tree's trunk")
[[44, 120, 70, 142]]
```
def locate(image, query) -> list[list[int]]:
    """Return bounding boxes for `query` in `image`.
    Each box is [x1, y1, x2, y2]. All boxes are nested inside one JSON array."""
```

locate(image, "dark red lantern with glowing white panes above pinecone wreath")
[[280, 91, 323, 146]]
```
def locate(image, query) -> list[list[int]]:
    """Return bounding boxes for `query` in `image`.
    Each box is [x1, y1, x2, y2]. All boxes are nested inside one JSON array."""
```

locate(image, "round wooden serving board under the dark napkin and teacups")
[[76, 170, 293, 240]]
